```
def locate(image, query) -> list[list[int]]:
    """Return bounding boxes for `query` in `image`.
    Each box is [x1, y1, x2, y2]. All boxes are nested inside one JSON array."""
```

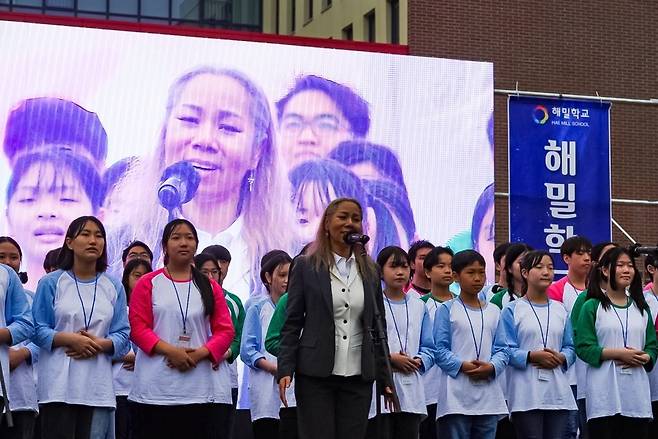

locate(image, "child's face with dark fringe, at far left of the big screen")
[[7, 162, 94, 276]]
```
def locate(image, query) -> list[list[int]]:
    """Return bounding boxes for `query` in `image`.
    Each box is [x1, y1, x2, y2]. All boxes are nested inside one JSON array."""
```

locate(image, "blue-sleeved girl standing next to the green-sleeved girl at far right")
[[494, 250, 576, 438]]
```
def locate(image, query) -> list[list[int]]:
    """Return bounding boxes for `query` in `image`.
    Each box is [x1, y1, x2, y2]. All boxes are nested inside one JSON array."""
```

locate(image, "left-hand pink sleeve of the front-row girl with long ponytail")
[[128, 275, 160, 355]]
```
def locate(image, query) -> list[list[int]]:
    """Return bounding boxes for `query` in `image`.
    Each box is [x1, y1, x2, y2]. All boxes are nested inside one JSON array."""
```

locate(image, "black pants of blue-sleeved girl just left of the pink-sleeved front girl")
[[39, 402, 94, 439]]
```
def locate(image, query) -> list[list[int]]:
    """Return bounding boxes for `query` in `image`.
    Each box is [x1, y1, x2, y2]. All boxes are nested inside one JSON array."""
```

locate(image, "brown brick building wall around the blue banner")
[[408, 0, 658, 248]]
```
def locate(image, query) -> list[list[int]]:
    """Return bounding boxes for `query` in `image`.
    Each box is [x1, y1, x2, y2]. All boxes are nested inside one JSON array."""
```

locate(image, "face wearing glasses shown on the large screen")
[[280, 90, 354, 169]]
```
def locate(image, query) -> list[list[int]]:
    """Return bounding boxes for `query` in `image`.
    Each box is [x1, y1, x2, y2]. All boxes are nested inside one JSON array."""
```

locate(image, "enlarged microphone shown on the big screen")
[[158, 161, 201, 211]]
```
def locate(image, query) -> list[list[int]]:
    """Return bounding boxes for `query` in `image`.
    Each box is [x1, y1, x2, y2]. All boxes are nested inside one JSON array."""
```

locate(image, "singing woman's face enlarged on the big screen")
[[164, 74, 258, 200]]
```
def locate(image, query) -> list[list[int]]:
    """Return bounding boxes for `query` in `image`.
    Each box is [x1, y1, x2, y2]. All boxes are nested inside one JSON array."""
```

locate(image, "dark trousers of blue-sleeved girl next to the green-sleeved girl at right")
[[512, 410, 568, 439]]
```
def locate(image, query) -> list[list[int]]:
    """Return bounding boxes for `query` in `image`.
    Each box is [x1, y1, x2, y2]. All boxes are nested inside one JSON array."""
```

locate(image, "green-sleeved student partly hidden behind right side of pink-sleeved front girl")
[[194, 250, 246, 439]]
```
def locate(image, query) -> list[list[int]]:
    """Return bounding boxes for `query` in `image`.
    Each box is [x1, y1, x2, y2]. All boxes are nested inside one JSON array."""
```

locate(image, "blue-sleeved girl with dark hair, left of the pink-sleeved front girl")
[[32, 216, 130, 439]]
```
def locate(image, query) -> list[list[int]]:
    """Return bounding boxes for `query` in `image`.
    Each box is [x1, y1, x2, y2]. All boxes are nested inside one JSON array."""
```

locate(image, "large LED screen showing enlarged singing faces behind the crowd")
[[0, 17, 494, 300]]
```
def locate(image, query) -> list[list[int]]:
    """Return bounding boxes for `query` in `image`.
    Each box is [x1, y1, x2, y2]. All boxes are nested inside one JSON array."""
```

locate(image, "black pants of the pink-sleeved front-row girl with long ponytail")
[[129, 402, 220, 439]]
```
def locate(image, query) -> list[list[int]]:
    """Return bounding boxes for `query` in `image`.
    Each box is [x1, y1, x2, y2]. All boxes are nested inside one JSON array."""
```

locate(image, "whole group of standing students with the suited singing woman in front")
[[0, 198, 658, 439]]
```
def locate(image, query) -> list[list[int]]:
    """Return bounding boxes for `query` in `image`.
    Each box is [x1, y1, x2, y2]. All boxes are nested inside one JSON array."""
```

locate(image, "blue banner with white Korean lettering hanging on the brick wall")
[[507, 96, 612, 274]]
